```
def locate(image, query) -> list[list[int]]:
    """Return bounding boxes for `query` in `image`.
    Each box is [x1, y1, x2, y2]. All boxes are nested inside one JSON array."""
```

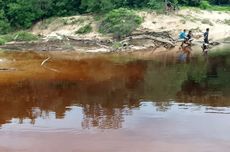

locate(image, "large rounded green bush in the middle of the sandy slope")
[[99, 8, 142, 38]]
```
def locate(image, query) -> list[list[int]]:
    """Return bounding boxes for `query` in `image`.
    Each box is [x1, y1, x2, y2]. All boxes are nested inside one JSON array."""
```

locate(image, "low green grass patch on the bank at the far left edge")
[[0, 31, 38, 45]]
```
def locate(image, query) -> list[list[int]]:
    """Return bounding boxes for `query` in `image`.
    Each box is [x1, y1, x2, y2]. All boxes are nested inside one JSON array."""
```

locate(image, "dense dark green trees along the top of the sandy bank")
[[0, 0, 230, 34]]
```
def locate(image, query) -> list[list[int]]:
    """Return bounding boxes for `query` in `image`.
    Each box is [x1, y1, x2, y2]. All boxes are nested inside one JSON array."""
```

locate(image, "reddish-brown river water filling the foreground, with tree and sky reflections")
[[0, 47, 230, 152]]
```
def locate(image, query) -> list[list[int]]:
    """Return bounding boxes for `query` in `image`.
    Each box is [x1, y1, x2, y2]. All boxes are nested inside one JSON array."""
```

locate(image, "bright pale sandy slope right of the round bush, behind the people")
[[138, 9, 230, 41]]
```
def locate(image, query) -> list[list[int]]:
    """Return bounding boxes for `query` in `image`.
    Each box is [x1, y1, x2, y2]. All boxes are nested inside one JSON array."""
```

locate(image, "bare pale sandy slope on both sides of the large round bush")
[[32, 9, 230, 41]]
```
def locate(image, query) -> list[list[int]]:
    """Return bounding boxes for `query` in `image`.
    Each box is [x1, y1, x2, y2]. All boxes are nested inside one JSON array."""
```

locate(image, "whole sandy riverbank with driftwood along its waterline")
[[0, 8, 230, 56]]
